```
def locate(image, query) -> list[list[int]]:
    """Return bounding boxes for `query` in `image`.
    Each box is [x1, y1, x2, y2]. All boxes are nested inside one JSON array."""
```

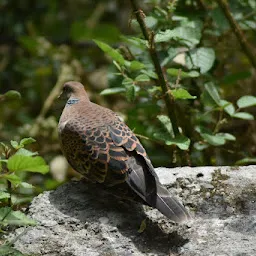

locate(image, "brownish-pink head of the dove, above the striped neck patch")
[[59, 81, 89, 100]]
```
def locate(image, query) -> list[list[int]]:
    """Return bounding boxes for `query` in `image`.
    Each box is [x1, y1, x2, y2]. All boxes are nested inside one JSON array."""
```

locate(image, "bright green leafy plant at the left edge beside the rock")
[[0, 138, 49, 230]]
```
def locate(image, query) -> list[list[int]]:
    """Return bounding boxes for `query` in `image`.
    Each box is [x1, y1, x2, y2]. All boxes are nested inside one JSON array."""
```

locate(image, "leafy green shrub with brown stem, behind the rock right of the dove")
[[94, 0, 256, 165]]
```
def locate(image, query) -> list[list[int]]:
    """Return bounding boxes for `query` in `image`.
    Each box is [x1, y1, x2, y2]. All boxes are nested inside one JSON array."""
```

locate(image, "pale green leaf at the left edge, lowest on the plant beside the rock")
[[0, 207, 36, 226]]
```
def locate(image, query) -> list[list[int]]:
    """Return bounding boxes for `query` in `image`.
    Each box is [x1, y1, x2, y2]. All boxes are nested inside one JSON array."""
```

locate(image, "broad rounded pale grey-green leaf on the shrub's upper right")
[[186, 47, 215, 74]]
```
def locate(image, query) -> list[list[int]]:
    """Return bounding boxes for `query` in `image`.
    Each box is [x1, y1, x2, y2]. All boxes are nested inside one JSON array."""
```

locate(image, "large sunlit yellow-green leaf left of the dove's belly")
[[7, 155, 49, 174]]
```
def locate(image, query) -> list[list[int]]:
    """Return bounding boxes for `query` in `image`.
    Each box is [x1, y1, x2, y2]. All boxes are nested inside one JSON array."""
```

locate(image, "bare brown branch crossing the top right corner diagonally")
[[217, 0, 256, 69]]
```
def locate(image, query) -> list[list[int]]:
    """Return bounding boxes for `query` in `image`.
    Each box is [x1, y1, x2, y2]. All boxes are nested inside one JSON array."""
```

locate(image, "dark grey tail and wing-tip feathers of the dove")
[[126, 155, 190, 222]]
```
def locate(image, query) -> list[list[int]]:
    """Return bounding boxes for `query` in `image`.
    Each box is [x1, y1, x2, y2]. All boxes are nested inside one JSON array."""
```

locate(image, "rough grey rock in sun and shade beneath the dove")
[[10, 166, 256, 256]]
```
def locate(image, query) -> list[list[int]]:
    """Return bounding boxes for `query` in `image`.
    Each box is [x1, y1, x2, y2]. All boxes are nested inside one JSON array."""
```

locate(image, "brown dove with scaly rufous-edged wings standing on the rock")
[[58, 81, 190, 223]]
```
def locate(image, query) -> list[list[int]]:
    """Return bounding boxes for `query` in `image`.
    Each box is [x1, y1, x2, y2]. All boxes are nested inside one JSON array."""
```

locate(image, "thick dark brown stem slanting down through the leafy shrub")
[[130, 0, 179, 136]]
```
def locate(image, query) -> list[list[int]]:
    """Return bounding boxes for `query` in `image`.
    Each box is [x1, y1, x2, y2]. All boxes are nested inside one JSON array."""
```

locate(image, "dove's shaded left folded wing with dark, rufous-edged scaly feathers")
[[61, 120, 132, 185]]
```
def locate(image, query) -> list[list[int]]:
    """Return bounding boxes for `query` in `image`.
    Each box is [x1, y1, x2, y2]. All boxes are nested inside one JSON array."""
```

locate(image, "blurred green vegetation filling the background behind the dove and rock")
[[0, 0, 256, 252]]
